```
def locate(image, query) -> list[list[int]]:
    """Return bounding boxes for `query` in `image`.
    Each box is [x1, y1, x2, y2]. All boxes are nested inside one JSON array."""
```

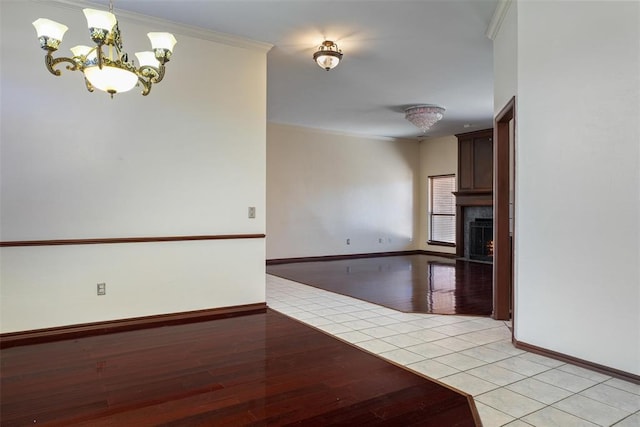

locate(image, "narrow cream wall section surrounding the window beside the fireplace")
[[418, 135, 458, 254]]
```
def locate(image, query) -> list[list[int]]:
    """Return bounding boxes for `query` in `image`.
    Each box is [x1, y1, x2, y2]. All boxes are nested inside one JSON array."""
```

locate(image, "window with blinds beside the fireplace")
[[429, 175, 456, 246]]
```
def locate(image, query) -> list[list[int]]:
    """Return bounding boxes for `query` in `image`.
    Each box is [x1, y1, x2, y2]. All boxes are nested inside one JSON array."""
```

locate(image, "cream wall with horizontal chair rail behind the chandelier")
[[0, 1, 266, 332]]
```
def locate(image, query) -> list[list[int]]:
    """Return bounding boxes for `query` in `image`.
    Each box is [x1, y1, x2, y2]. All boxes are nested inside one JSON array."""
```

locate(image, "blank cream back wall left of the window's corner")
[[267, 124, 419, 259]]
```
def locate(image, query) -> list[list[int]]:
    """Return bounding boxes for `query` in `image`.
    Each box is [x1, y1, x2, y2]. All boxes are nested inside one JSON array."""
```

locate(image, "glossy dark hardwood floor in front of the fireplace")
[[267, 255, 493, 316]]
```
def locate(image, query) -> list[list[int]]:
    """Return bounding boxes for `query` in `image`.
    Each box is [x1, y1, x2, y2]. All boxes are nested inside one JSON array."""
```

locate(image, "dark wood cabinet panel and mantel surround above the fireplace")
[[454, 129, 493, 258]]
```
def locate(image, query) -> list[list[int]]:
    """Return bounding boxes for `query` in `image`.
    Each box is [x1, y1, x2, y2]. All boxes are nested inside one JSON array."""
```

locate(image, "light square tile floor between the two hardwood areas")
[[267, 275, 640, 427]]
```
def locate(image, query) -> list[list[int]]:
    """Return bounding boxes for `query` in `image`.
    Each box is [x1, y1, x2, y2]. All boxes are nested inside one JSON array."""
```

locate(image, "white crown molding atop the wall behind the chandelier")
[[35, 0, 273, 53]]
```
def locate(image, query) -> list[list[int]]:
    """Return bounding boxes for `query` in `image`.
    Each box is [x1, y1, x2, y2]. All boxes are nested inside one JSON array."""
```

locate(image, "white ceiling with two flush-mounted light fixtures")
[[114, 0, 498, 138]]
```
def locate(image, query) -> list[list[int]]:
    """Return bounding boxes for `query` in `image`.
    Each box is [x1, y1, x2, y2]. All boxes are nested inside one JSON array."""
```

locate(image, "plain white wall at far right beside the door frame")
[[496, 1, 640, 375]]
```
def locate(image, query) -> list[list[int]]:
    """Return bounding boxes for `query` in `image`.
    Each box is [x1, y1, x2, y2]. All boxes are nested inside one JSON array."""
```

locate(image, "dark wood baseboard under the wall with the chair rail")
[[0, 302, 267, 348]]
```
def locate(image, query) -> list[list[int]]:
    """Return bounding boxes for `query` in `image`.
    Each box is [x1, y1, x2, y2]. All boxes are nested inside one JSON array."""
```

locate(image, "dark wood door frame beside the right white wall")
[[493, 97, 516, 320]]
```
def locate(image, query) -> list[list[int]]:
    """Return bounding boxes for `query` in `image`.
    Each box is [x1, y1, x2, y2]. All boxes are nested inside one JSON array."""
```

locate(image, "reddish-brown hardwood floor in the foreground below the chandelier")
[[0, 310, 476, 427]]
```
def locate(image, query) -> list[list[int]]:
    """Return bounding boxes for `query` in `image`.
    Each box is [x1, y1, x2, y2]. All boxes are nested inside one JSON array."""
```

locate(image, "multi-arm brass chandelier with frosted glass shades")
[[33, 1, 176, 98]]
